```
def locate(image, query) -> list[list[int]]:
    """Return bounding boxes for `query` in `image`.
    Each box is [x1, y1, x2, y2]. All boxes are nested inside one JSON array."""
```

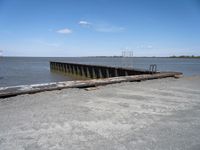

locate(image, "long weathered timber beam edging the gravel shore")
[[0, 72, 182, 98]]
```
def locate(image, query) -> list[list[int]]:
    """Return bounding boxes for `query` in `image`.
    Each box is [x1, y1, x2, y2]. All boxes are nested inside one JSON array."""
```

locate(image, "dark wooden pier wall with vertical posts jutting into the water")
[[50, 62, 153, 79]]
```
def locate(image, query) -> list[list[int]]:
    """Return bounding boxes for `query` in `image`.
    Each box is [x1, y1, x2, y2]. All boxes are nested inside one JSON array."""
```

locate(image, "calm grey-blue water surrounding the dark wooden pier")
[[0, 57, 200, 87]]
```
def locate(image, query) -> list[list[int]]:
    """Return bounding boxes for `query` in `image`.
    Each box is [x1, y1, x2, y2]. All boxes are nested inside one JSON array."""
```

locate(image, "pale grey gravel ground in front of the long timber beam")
[[0, 76, 200, 150]]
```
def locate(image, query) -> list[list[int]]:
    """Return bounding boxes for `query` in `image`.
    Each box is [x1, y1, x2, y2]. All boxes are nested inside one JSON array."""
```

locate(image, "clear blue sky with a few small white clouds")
[[0, 0, 200, 57]]
